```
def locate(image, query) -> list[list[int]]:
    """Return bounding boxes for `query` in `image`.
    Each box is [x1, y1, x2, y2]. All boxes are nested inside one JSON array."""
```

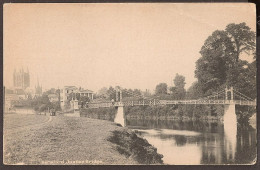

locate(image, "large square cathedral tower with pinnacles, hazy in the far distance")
[[13, 68, 30, 90]]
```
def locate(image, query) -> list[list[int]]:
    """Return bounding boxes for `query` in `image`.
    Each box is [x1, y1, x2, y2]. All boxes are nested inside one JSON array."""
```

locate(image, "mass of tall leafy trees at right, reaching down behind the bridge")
[[193, 23, 256, 120]]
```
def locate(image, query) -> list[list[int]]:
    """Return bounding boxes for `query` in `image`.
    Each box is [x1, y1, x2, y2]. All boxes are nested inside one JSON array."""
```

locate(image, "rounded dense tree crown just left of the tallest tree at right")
[[195, 30, 235, 93]]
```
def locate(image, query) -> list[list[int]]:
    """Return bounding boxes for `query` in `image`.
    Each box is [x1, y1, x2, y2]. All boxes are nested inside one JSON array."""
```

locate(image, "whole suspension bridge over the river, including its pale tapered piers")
[[67, 87, 256, 128]]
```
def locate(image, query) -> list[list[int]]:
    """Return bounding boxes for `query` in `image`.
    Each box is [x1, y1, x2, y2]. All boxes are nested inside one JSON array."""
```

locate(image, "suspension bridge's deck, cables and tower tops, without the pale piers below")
[[87, 87, 256, 108]]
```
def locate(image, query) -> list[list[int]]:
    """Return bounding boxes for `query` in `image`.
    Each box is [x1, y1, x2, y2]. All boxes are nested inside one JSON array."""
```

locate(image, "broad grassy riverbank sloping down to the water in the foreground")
[[4, 114, 162, 165]]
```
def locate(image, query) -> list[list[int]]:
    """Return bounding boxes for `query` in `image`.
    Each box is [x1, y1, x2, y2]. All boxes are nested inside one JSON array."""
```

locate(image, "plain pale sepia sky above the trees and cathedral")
[[4, 3, 256, 92]]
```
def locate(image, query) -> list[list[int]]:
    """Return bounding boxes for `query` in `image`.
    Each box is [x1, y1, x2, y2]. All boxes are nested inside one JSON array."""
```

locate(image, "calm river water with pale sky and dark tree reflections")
[[125, 119, 257, 165]]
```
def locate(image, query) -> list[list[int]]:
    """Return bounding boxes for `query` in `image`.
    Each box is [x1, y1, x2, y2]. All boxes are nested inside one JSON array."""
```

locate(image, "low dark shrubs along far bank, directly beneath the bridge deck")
[[80, 105, 224, 121]]
